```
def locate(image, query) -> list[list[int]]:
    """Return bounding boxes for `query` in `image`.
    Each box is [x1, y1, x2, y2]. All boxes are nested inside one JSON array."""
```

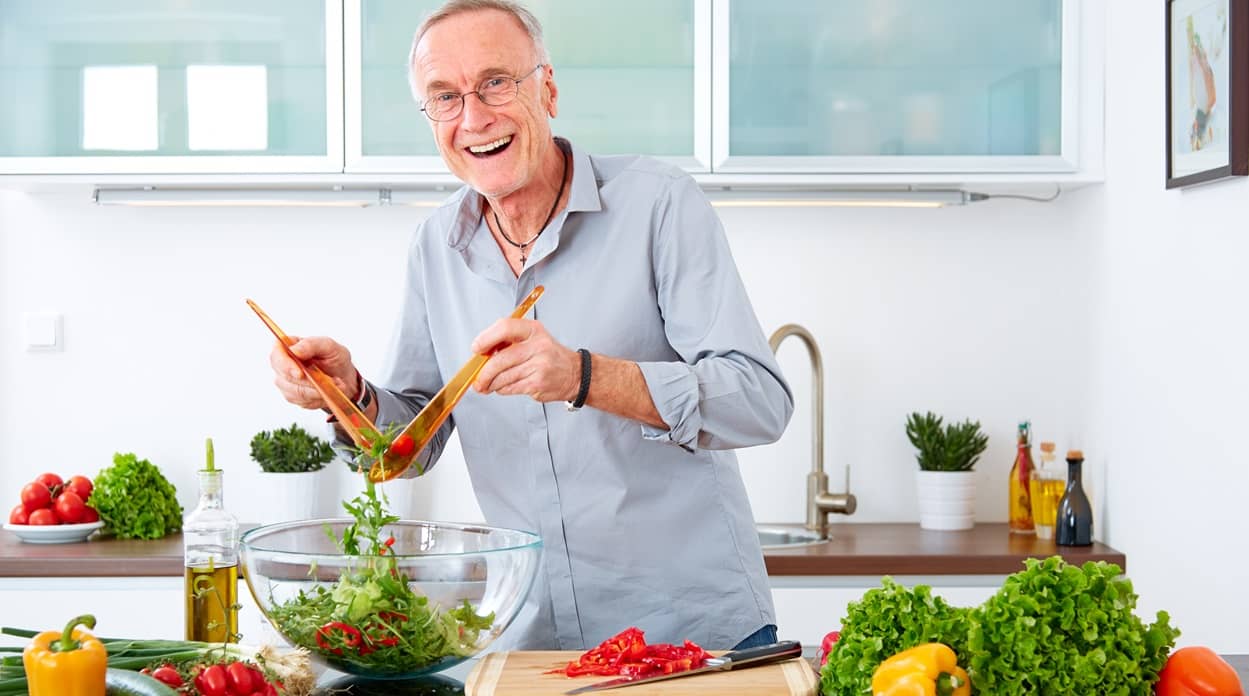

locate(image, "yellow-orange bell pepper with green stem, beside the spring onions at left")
[[21, 614, 109, 696]]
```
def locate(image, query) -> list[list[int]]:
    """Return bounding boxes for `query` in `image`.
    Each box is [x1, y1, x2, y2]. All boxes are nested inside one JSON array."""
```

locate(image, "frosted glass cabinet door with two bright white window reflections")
[[0, 0, 342, 174]]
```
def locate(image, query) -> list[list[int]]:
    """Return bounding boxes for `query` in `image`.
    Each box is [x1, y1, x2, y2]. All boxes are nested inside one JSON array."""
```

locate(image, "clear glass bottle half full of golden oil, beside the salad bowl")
[[182, 439, 239, 642]]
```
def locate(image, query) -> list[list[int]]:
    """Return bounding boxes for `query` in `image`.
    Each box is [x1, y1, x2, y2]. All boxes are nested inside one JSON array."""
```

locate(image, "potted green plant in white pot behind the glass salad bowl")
[[251, 424, 335, 524]]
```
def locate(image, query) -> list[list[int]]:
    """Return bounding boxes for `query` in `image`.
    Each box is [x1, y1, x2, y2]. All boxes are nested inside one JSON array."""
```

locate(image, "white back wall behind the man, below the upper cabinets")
[[0, 190, 1100, 522]]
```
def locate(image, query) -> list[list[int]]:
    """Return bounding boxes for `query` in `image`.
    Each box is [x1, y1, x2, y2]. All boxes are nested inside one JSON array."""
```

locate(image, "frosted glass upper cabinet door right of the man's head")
[[713, 0, 1077, 172]]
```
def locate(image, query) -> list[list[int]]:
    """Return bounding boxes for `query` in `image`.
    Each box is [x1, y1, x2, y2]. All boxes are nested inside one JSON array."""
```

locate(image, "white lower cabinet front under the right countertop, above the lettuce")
[[768, 575, 1007, 649]]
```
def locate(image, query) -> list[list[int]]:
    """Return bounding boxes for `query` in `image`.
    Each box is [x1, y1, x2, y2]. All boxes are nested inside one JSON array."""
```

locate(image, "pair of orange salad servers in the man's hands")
[[247, 285, 545, 484]]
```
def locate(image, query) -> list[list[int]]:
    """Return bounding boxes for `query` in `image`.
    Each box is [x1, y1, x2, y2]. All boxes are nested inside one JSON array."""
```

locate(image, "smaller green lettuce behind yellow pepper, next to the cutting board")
[[819, 576, 974, 696]]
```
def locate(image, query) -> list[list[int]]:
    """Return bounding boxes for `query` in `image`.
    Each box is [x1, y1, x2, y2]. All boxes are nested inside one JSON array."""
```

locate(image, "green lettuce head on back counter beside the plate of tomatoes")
[[87, 454, 182, 539]]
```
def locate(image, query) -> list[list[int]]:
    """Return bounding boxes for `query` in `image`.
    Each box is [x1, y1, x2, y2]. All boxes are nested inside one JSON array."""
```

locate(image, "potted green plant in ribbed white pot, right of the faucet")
[[907, 412, 989, 530]]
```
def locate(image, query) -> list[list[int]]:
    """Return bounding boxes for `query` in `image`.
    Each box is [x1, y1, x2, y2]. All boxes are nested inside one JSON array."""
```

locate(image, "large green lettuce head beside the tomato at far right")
[[964, 556, 1179, 696]]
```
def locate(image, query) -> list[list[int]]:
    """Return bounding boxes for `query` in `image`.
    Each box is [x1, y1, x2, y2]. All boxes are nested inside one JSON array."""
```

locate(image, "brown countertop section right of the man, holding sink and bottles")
[[763, 522, 1128, 576]]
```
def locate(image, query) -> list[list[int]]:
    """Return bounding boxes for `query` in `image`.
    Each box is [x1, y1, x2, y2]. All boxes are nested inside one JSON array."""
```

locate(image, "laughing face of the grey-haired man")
[[412, 10, 557, 197]]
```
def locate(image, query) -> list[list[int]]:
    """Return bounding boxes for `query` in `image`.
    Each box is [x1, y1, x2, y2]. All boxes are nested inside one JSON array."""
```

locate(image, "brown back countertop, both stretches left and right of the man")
[[0, 522, 1127, 577]]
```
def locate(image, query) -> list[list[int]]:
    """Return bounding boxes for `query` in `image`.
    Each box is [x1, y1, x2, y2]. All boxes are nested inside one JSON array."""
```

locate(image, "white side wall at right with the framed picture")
[[1095, 0, 1249, 652]]
